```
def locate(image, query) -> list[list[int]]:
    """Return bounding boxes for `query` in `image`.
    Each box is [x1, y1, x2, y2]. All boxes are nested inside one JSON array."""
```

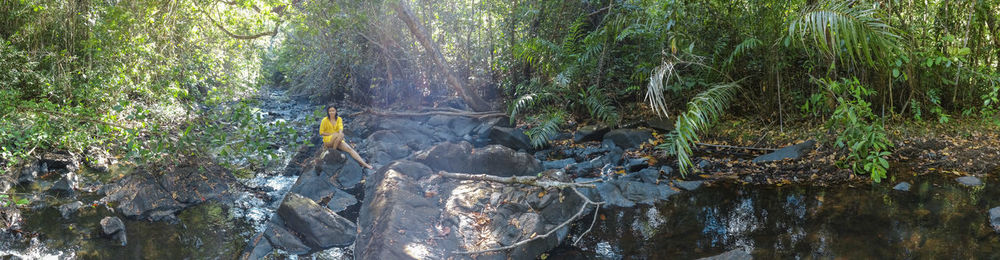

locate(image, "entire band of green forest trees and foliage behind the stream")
[[0, 0, 1000, 181]]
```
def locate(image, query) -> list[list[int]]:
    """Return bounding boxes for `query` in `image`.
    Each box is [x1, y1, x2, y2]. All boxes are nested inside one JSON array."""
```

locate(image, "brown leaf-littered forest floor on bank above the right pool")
[[568, 118, 1000, 186]]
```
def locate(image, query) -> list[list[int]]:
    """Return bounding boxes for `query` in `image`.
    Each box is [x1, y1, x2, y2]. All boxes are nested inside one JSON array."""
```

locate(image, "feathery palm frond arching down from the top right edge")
[[788, 0, 899, 66]]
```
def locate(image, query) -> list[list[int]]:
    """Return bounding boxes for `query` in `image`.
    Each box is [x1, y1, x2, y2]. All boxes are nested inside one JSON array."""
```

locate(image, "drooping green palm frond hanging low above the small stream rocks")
[[658, 83, 740, 175]]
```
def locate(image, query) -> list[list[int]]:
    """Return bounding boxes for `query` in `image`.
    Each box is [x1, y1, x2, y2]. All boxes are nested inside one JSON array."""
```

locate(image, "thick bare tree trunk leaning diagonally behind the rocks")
[[392, 0, 490, 111]]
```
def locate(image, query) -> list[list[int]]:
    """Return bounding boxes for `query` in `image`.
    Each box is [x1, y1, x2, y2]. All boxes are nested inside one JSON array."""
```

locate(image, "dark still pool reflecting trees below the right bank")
[[580, 176, 1000, 259]]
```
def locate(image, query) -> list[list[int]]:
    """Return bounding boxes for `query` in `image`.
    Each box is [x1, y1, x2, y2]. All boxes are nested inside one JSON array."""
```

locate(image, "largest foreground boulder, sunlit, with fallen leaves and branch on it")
[[355, 161, 582, 259]]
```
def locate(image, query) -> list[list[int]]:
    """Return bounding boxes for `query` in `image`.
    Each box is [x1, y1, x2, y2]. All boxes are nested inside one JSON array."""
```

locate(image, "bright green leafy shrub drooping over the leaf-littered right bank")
[[818, 79, 893, 182]]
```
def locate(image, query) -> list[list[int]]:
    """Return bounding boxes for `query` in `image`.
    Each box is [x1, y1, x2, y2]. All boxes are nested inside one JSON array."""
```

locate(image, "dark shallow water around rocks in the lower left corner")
[[0, 203, 252, 259]]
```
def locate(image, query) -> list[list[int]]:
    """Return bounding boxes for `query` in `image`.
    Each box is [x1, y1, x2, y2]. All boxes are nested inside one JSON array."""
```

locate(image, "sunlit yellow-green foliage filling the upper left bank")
[[0, 0, 281, 174]]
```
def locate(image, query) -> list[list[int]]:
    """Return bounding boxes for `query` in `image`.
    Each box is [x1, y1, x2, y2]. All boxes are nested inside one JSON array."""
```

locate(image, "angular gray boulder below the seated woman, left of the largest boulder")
[[272, 192, 357, 250]]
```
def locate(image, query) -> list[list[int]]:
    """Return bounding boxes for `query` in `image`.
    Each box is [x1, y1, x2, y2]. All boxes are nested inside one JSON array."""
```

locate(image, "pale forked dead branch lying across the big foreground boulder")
[[438, 171, 604, 255]]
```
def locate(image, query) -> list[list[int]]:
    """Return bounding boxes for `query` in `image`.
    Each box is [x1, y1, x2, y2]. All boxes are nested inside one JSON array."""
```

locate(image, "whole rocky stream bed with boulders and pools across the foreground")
[[0, 90, 1000, 259]]
